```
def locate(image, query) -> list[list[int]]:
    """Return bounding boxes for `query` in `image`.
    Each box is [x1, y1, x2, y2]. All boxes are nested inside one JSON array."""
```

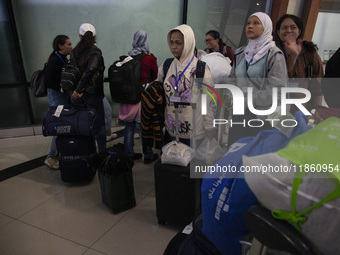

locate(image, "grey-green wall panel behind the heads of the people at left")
[[13, 0, 182, 80]]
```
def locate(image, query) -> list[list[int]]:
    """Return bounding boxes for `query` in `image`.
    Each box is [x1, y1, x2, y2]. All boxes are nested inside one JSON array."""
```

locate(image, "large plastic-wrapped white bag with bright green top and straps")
[[243, 117, 340, 255]]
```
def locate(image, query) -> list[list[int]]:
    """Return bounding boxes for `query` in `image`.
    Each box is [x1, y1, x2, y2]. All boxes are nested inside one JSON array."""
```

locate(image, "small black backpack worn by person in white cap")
[[60, 59, 81, 91]]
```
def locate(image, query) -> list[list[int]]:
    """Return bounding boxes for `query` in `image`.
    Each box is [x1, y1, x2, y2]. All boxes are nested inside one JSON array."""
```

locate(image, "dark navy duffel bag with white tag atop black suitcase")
[[42, 104, 101, 136]]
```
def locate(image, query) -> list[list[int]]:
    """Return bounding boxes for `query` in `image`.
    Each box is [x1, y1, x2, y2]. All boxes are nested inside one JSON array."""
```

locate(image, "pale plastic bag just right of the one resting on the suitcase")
[[196, 137, 224, 164]]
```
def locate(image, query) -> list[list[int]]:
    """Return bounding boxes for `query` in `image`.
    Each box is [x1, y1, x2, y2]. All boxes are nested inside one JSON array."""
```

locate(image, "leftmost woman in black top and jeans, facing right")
[[44, 35, 72, 169]]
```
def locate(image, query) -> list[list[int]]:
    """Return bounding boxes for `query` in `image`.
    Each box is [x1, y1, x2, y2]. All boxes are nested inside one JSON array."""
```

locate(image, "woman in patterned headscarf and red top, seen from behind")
[[119, 30, 158, 161]]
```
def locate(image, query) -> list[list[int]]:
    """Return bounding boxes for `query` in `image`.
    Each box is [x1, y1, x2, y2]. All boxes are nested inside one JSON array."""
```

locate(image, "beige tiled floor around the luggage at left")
[[0, 125, 179, 255]]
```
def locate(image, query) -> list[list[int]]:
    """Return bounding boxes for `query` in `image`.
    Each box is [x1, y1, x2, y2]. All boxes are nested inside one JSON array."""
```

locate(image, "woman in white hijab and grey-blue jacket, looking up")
[[228, 12, 288, 146]]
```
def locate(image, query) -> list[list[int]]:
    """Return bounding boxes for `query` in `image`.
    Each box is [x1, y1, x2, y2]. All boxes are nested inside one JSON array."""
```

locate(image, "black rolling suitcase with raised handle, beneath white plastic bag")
[[154, 103, 201, 227]]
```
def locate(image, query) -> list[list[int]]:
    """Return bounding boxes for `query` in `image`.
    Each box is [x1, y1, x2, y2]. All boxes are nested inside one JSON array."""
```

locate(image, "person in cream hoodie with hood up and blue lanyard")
[[157, 25, 216, 146]]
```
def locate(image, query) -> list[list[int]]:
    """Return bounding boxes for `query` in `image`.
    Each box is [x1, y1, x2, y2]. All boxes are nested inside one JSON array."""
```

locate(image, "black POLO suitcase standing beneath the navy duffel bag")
[[56, 136, 96, 182]]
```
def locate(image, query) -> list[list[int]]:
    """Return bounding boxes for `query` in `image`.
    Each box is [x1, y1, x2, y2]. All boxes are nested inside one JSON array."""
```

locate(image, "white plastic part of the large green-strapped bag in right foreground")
[[243, 151, 340, 254]]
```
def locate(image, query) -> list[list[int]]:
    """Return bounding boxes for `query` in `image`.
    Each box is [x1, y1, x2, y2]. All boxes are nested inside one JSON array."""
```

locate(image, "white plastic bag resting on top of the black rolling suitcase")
[[161, 141, 195, 166]]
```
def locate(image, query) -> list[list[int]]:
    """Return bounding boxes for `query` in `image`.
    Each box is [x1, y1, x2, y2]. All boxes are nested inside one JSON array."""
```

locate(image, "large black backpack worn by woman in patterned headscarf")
[[108, 53, 145, 104]]
